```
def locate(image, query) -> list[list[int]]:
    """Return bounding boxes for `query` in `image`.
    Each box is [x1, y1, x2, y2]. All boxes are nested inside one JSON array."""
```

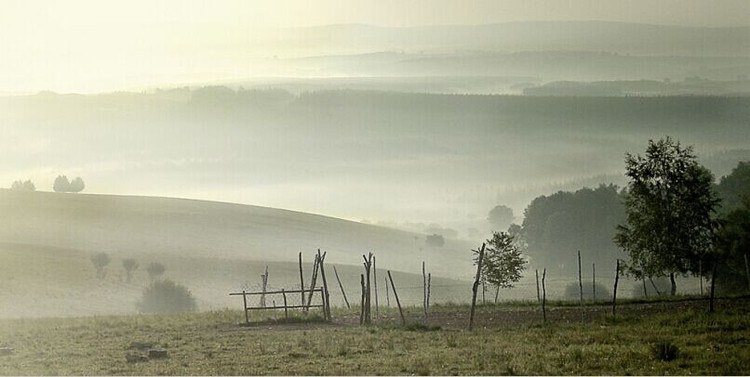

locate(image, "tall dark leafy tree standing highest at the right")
[[615, 137, 719, 295]]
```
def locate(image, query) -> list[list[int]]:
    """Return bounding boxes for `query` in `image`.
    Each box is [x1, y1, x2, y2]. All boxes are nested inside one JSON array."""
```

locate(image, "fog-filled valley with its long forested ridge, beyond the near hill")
[[0, 91, 750, 232]]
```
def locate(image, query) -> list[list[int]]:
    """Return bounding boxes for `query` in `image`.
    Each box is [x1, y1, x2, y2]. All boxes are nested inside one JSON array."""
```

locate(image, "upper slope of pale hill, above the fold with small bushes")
[[0, 189, 480, 277]]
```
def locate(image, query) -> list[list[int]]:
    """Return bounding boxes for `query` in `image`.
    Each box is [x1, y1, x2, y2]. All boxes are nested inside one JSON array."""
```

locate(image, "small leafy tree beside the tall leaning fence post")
[[474, 232, 527, 296]]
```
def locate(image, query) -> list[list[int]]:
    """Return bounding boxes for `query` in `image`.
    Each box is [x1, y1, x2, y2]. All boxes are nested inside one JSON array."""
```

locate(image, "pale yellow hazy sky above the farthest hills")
[[0, 0, 750, 93]]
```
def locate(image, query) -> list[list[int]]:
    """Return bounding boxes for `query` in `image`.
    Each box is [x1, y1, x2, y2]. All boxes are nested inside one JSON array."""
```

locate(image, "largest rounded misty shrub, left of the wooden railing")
[[137, 279, 198, 313]]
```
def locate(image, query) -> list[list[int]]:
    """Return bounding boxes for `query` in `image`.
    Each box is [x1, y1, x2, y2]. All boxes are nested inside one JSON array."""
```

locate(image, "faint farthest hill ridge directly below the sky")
[[270, 21, 750, 56]]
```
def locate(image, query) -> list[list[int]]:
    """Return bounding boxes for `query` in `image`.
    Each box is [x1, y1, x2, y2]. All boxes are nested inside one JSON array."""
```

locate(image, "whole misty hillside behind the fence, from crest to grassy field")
[[0, 189, 482, 317]]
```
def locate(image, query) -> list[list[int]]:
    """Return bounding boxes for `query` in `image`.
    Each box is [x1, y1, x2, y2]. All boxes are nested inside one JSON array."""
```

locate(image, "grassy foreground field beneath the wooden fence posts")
[[0, 298, 750, 375]]
